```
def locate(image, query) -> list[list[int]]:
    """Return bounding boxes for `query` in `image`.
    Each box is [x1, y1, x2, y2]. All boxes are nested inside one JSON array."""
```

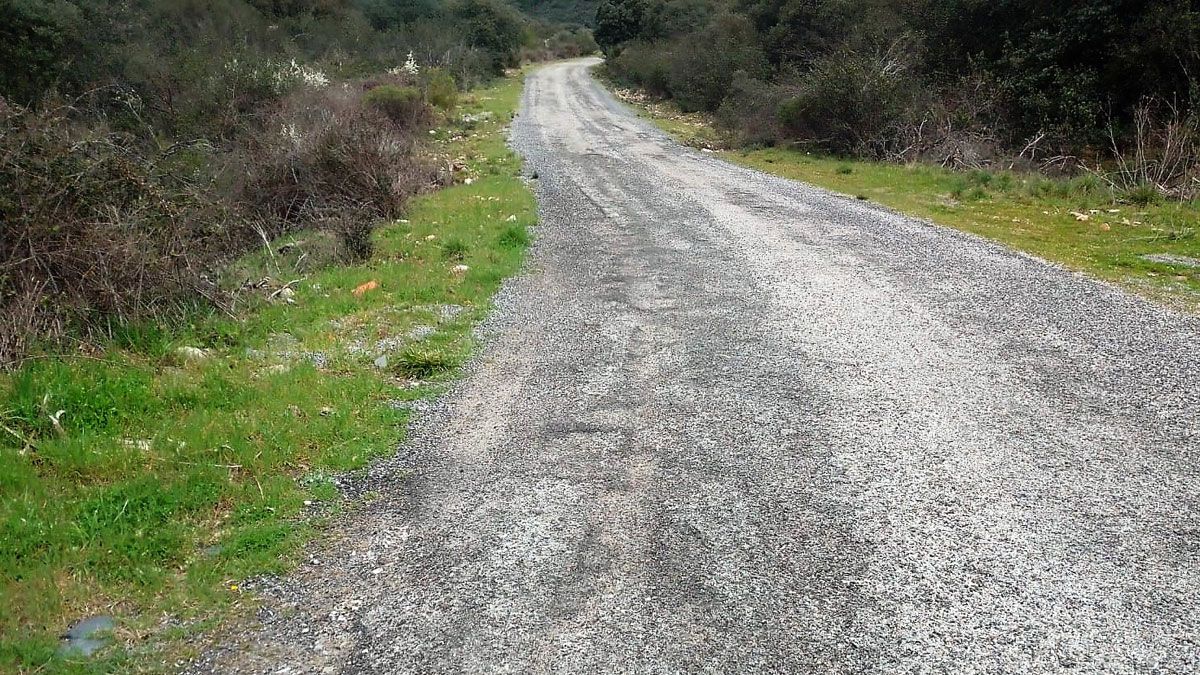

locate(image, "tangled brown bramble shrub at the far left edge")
[[0, 100, 220, 363]]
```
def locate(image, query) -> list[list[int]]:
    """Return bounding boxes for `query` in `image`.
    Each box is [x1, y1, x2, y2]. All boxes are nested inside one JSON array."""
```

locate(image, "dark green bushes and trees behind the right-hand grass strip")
[[596, 0, 1200, 195]]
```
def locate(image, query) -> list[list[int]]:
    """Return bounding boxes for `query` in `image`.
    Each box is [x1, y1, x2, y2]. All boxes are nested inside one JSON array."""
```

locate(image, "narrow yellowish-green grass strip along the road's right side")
[[609, 85, 1200, 312]]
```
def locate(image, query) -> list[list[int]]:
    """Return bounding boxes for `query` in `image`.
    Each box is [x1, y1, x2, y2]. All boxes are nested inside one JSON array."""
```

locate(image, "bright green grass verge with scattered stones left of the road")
[[0, 70, 535, 673]]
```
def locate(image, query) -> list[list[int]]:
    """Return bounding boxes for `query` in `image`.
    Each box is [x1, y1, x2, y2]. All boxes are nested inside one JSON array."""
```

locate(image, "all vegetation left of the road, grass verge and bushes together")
[[0, 0, 596, 673]]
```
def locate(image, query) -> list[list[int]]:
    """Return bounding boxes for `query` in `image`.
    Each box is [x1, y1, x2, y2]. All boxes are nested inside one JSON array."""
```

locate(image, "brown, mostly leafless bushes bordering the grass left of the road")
[[0, 72, 432, 360]]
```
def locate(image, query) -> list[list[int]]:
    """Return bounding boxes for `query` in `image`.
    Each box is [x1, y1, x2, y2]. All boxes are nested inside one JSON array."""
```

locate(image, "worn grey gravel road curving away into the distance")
[[191, 60, 1200, 673]]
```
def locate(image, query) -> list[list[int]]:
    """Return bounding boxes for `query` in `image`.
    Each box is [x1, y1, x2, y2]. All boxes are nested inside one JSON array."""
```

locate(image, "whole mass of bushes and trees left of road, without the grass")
[[0, 0, 594, 365]]
